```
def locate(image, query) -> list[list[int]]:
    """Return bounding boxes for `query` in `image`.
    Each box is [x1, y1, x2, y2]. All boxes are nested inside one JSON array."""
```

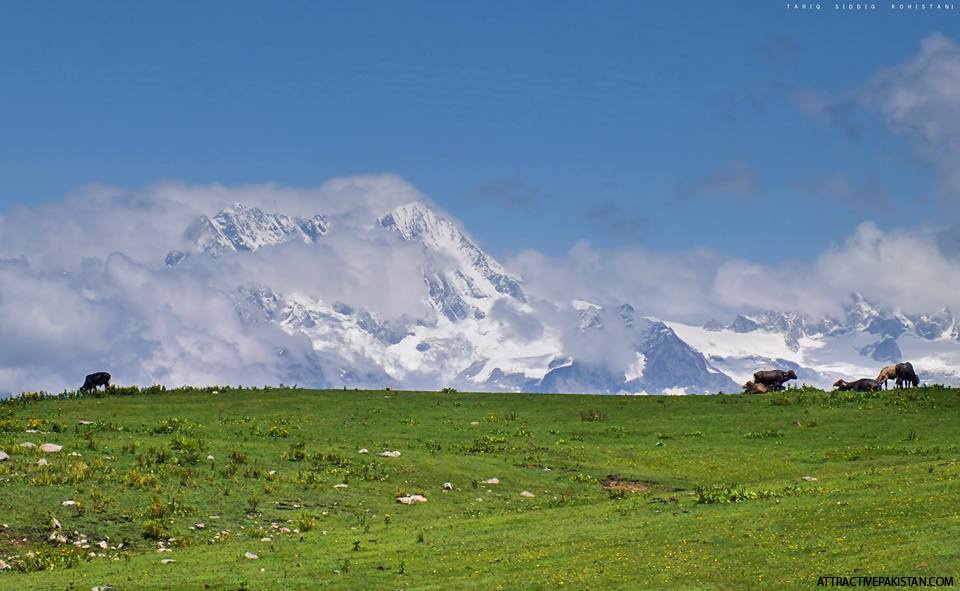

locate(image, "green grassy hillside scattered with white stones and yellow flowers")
[[0, 388, 960, 591]]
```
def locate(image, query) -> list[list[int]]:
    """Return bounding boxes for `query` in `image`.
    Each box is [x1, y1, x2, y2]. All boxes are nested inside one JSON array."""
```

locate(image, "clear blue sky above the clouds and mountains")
[[0, 1, 960, 263]]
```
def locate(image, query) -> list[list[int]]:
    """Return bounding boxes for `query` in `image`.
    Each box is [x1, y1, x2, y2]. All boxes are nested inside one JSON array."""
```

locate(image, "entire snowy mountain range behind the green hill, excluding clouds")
[[165, 202, 960, 394]]
